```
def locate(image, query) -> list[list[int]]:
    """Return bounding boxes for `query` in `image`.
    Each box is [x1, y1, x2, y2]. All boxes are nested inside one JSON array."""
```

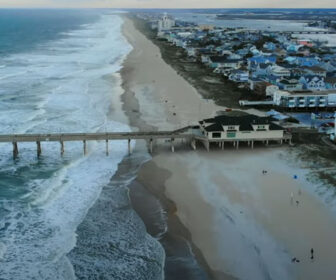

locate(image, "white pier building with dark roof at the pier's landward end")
[[199, 115, 284, 145]]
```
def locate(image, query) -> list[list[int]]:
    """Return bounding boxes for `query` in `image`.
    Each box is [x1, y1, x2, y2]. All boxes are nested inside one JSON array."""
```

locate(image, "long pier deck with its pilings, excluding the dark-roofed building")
[[0, 126, 292, 159]]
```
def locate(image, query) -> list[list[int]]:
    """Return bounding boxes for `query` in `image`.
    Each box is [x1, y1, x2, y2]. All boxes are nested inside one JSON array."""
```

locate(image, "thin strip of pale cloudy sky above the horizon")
[[0, 0, 336, 8]]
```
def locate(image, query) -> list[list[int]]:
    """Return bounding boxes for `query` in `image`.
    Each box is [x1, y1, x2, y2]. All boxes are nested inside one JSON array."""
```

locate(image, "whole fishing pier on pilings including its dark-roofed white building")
[[0, 110, 292, 159]]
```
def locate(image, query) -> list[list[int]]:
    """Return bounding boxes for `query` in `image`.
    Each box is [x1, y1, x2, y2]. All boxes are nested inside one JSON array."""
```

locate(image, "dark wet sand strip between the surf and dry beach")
[[120, 16, 217, 280]]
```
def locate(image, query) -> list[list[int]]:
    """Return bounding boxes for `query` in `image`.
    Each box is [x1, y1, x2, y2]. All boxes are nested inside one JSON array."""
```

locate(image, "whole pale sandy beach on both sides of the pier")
[[121, 17, 336, 280]]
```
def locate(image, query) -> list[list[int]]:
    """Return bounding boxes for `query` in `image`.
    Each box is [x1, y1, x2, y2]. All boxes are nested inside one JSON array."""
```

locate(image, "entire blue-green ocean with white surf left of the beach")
[[0, 10, 165, 280]]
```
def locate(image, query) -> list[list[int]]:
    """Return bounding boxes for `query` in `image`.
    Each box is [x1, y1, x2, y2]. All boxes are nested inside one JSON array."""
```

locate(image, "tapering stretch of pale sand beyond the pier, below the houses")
[[124, 18, 223, 129]]
